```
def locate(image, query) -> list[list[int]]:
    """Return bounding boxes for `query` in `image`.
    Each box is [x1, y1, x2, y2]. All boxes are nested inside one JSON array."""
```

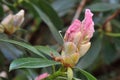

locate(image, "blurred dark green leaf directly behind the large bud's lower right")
[[76, 35, 102, 69]]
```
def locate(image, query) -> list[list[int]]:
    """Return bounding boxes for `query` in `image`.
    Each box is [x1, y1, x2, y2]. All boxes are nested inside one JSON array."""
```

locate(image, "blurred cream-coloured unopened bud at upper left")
[[1, 10, 24, 34]]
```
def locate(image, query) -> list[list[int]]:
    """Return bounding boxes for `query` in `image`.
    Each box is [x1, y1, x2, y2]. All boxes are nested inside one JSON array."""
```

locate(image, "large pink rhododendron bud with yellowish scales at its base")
[[61, 9, 94, 67]]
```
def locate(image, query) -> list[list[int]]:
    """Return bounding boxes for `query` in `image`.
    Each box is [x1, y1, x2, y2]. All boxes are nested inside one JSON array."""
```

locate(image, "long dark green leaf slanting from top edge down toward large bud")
[[26, 0, 63, 45]]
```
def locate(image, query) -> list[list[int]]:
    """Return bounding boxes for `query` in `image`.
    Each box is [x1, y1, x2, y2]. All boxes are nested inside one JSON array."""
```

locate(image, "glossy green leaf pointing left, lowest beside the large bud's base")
[[9, 58, 60, 71]]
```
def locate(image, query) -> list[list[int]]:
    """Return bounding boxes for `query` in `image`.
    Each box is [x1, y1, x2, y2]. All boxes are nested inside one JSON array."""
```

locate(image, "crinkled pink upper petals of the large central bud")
[[64, 9, 94, 44]]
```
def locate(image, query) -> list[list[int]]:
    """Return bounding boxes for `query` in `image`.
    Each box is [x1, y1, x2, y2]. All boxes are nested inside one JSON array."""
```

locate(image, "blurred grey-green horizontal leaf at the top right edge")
[[88, 3, 120, 12]]
